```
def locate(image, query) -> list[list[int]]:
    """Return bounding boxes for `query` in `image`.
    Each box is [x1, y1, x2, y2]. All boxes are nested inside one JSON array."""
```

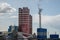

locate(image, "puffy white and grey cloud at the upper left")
[[0, 3, 16, 15]]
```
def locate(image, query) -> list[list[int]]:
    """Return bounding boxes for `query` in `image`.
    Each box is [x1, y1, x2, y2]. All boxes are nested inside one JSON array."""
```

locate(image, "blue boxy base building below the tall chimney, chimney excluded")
[[37, 28, 47, 40]]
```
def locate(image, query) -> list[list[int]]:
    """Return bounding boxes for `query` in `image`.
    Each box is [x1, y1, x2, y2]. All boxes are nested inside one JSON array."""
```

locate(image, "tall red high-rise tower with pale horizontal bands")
[[18, 7, 32, 34]]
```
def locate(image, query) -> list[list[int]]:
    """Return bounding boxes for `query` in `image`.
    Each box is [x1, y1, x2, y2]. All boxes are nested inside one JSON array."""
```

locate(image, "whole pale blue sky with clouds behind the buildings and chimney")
[[0, 0, 60, 35]]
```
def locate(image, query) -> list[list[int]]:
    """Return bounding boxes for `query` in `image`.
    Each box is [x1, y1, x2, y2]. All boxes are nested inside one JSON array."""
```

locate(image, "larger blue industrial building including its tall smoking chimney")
[[37, 4, 47, 40]]
